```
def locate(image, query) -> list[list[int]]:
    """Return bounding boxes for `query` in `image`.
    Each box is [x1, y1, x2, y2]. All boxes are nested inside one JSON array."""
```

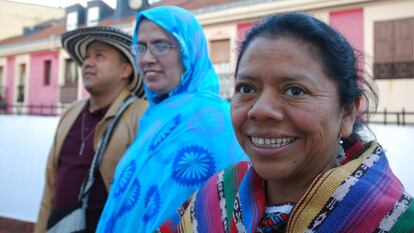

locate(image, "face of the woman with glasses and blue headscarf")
[[137, 20, 184, 95]]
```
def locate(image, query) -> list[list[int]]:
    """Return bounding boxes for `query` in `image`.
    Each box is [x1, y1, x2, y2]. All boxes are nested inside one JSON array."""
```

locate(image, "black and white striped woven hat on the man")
[[62, 27, 144, 97]]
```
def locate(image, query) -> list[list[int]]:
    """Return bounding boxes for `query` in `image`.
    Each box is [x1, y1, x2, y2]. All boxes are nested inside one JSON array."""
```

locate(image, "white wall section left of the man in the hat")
[[0, 115, 59, 222]]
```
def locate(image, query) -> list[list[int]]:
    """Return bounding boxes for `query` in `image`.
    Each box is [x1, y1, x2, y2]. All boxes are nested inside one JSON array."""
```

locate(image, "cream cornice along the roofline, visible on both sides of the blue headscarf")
[[0, 0, 386, 57]]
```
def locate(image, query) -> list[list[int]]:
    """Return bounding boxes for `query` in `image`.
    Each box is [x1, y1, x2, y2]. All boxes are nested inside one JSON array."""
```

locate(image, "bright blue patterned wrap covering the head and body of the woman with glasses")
[[97, 7, 247, 232]]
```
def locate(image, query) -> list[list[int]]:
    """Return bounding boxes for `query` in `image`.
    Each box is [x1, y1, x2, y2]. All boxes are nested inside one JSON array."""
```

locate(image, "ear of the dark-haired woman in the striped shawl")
[[340, 97, 362, 138]]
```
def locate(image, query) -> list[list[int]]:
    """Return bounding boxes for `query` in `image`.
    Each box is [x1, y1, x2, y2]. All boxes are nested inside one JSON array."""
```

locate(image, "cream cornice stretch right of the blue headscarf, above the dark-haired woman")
[[194, 0, 381, 26]]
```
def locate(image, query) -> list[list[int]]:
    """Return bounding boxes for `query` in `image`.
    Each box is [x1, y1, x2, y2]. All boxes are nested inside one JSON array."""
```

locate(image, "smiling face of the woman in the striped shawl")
[[231, 37, 355, 182]]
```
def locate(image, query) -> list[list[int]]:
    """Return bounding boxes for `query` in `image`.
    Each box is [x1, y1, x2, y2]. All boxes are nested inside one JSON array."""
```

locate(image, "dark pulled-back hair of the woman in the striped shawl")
[[236, 12, 378, 144]]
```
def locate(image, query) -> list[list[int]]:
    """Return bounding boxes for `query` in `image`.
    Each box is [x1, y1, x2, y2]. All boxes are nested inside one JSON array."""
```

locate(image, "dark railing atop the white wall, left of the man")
[[0, 102, 69, 116]]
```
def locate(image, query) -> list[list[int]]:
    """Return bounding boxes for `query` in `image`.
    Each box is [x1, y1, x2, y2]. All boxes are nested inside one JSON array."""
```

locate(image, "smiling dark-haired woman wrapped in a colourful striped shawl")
[[160, 13, 414, 233]]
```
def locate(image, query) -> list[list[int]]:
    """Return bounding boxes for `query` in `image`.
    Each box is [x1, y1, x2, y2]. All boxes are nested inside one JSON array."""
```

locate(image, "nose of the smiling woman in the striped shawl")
[[247, 92, 284, 121]]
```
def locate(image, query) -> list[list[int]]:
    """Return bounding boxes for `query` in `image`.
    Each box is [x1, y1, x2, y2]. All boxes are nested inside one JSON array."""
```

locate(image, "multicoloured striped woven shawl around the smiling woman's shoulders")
[[160, 142, 414, 233]]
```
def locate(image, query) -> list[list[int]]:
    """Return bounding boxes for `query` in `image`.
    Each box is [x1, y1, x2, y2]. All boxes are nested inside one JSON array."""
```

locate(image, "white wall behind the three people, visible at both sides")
[[0, 115, 414, 222]]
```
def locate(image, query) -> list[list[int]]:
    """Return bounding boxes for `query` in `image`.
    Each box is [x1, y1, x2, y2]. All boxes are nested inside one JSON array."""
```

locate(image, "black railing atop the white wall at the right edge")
[[367, 109, 414, 125]]
